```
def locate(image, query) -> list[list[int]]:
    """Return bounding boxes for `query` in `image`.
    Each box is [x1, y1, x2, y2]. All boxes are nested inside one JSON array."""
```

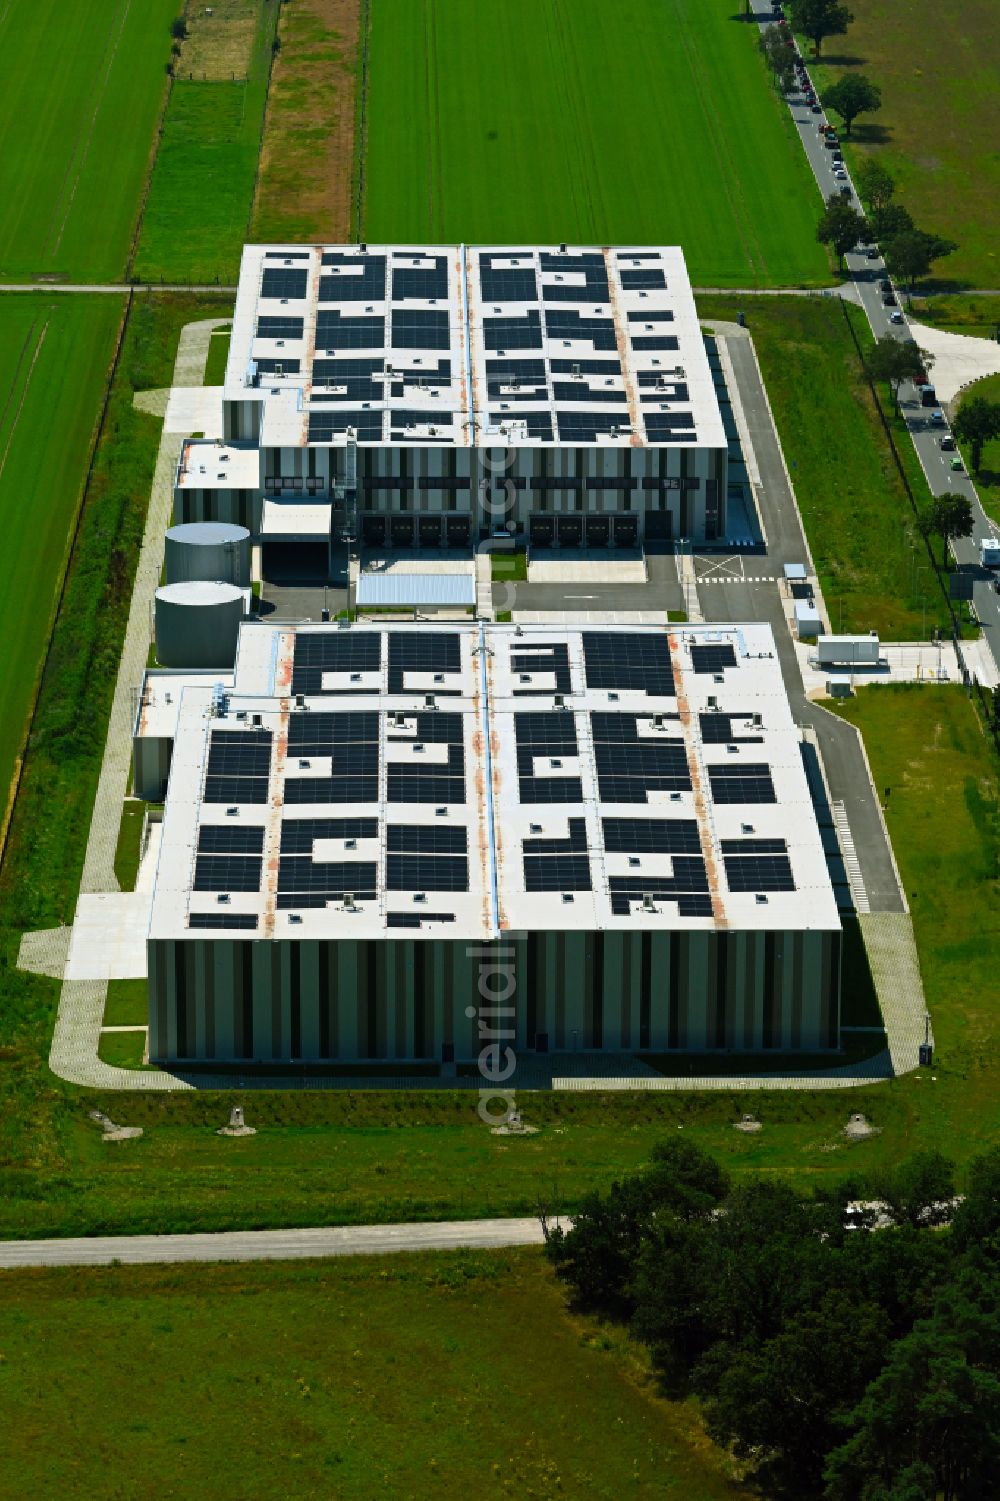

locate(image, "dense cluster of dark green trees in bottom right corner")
[[547, 1138, 1000, 1501]]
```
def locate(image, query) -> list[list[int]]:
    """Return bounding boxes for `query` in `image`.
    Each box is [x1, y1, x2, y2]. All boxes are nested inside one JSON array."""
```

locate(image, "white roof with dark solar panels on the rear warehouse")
[[224, 245, 727, 447]]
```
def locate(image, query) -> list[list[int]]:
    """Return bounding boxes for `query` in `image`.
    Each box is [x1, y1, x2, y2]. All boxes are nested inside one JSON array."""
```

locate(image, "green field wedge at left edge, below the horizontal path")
[[0, 291, 125, 821]]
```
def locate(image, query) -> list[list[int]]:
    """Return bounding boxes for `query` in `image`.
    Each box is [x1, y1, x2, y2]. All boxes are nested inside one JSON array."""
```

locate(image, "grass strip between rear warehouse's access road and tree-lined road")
[[698, 297, 947, 641]]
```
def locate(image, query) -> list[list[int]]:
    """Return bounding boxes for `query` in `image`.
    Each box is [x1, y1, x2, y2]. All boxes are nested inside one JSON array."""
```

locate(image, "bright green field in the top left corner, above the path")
[[0, 0, 173, 281]]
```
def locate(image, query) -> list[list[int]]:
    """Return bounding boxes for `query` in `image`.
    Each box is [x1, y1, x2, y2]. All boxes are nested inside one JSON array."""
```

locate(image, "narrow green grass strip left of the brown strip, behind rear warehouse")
[[134, 5, 278, 284]]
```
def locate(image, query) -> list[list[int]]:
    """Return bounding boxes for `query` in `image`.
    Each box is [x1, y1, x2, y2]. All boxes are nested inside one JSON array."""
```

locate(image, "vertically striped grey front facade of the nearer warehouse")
[[149, 929, 841, 1063]]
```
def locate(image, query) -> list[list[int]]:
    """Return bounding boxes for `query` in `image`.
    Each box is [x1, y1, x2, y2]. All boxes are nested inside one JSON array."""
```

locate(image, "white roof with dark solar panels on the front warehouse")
[[150, 621, 839, 940]]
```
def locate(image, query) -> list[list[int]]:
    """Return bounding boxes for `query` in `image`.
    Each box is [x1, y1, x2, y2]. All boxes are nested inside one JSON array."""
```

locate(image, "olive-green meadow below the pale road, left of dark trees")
[[0, 1254, 732, 1501]]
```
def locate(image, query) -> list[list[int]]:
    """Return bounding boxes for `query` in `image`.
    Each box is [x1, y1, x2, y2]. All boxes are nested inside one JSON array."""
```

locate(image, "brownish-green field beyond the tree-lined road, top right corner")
[[803, 0, 1000, 291]]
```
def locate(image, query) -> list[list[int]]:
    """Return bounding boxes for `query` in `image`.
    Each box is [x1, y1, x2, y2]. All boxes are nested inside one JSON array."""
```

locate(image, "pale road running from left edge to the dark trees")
[[0, 1219, 544, 1268]]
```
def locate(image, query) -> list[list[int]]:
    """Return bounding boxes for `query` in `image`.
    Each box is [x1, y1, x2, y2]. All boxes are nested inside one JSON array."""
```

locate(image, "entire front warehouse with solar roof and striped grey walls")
[[138, 621, 841, 1063]]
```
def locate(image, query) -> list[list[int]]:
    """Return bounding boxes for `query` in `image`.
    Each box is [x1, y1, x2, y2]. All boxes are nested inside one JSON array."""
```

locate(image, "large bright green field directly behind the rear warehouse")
[[365, 0, 829, 287]]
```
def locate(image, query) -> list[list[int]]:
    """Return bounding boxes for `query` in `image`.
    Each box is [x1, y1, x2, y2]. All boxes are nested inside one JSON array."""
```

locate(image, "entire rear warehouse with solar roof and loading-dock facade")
[[174, 245, 727, 573]]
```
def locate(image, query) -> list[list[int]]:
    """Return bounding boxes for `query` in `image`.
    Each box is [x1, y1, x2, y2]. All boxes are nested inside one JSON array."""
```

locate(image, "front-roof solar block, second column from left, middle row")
[[285, 710, 378, 805]]
